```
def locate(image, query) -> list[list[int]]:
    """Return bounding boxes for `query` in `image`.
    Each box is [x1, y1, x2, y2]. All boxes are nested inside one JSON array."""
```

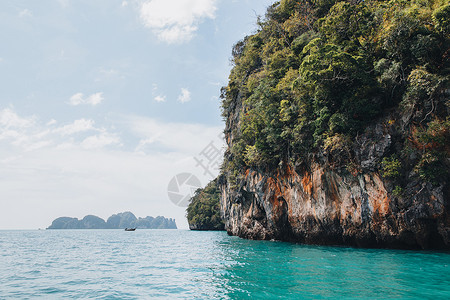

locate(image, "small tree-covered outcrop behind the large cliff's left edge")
[[187, 179, 224, 230]]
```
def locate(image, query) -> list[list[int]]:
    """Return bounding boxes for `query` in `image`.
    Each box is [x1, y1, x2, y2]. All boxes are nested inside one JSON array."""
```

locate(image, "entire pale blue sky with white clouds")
[[0, 0, 275, 229]]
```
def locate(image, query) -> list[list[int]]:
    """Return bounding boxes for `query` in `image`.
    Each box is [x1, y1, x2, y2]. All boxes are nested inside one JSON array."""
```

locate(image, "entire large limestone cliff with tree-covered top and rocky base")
[[218, 0, 450, 249]]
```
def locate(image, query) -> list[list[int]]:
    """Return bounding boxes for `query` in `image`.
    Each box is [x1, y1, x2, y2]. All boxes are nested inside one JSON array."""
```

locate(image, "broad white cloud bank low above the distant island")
[[0, 108, 221, 228]]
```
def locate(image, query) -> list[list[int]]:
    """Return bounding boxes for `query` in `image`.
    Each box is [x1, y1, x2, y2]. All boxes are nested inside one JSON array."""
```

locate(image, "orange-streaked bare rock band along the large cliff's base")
[[222, 163, 450, 249]]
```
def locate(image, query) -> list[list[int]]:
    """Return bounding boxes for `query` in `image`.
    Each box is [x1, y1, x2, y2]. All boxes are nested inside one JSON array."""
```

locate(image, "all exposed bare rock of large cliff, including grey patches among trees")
[[219, 95, 450, 249]]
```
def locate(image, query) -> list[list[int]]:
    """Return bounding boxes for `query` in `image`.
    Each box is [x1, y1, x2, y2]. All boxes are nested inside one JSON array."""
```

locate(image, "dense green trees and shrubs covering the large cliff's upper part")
[[222, 0, 450, 185]]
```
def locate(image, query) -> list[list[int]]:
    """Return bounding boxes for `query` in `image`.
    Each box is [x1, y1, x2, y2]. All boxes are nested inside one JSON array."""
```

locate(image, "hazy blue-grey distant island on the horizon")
[[47, 211, 177, 229]]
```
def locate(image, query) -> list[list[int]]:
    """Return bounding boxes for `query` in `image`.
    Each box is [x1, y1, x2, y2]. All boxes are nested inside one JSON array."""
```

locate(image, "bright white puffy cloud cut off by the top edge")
[[140, 0, 217, 44]]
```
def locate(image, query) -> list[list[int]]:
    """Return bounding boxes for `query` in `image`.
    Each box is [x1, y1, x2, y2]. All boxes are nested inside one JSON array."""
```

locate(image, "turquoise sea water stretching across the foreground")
[[0, 230, 450, 299]]
